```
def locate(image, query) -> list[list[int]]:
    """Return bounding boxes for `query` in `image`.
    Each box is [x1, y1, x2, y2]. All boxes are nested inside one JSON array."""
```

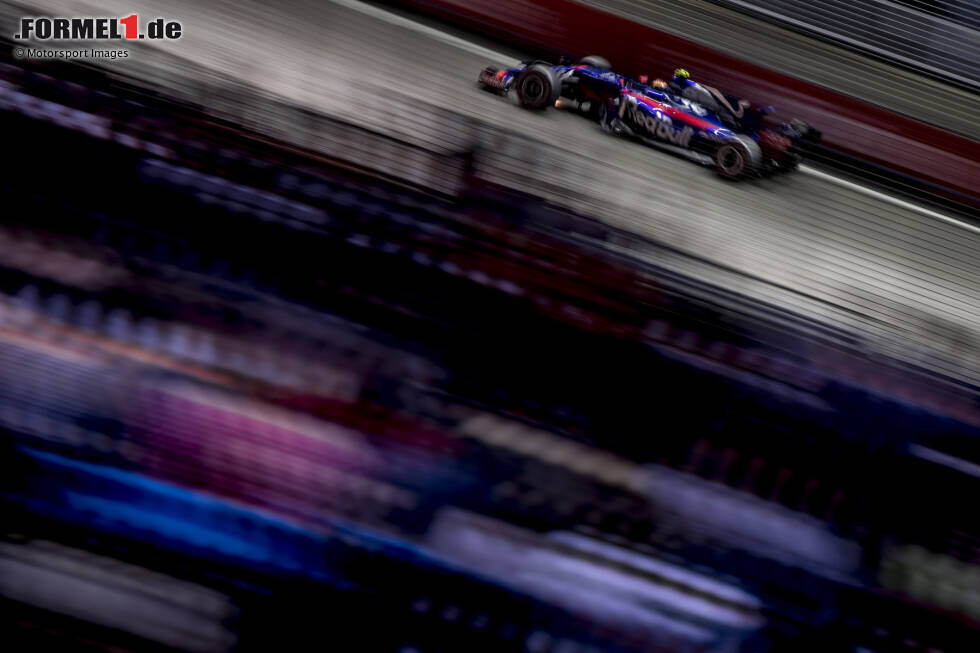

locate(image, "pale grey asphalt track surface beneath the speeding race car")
[[7, 0, 980, 384]]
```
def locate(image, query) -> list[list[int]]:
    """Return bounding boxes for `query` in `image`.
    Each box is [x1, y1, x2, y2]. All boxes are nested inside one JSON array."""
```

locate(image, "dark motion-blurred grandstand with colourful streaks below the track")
[[0, 3, 980, 653]]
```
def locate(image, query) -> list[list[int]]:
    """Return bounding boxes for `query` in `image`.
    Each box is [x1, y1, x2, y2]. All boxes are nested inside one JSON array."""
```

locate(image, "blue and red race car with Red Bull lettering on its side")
[[478, 56, 820, 179]]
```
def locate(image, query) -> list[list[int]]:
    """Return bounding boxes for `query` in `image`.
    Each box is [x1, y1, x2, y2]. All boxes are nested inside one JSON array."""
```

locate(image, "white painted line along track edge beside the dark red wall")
[[330, 0, 980, 234]]
